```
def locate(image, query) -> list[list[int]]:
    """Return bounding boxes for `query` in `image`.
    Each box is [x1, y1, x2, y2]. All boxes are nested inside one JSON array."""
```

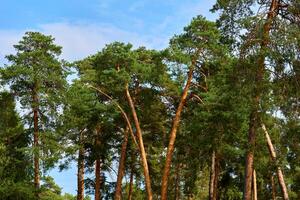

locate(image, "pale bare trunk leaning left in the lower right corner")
[[261, 123, 289, 200]]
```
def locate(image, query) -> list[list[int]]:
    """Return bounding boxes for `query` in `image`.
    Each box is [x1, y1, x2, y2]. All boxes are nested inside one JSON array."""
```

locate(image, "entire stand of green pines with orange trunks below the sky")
[[0, 0, 300, 200]]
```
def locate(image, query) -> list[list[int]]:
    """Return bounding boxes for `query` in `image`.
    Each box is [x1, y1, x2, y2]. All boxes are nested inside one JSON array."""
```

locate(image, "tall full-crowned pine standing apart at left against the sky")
[[1, 32, 66, 192]]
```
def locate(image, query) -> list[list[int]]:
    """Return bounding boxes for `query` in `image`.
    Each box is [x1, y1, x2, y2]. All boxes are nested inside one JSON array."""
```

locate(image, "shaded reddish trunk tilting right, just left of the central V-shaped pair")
[[115, 127, 129, 200]]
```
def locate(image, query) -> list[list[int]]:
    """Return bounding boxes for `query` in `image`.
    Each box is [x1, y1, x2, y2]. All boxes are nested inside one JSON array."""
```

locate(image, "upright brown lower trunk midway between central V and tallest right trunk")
[[209, 151, 220, 200]]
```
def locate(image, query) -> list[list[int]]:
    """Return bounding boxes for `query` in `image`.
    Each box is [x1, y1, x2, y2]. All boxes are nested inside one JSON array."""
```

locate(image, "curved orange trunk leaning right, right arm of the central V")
[[161, 65, 195, 200]]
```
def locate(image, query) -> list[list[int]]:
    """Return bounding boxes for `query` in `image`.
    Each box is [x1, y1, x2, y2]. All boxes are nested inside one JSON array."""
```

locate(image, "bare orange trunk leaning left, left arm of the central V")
[[126, 85, 153, 200]]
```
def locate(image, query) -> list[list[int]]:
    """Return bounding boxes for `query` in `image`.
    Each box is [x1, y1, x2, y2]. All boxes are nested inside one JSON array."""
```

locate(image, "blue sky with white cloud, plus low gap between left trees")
[[0, 0, 216, 194]]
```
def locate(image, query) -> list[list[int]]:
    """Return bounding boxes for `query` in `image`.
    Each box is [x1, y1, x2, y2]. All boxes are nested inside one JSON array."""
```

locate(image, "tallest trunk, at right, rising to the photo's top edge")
[[244, 0, 278, 200]]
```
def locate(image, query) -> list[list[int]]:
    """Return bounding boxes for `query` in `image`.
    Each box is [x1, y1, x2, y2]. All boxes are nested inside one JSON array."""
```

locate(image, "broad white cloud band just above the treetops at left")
[[0, 22, 168, 63]]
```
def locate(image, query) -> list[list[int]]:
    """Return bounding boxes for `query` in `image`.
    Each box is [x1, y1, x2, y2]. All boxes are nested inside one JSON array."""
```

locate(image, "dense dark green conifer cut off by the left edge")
[[0, 92, 33, 200]]
